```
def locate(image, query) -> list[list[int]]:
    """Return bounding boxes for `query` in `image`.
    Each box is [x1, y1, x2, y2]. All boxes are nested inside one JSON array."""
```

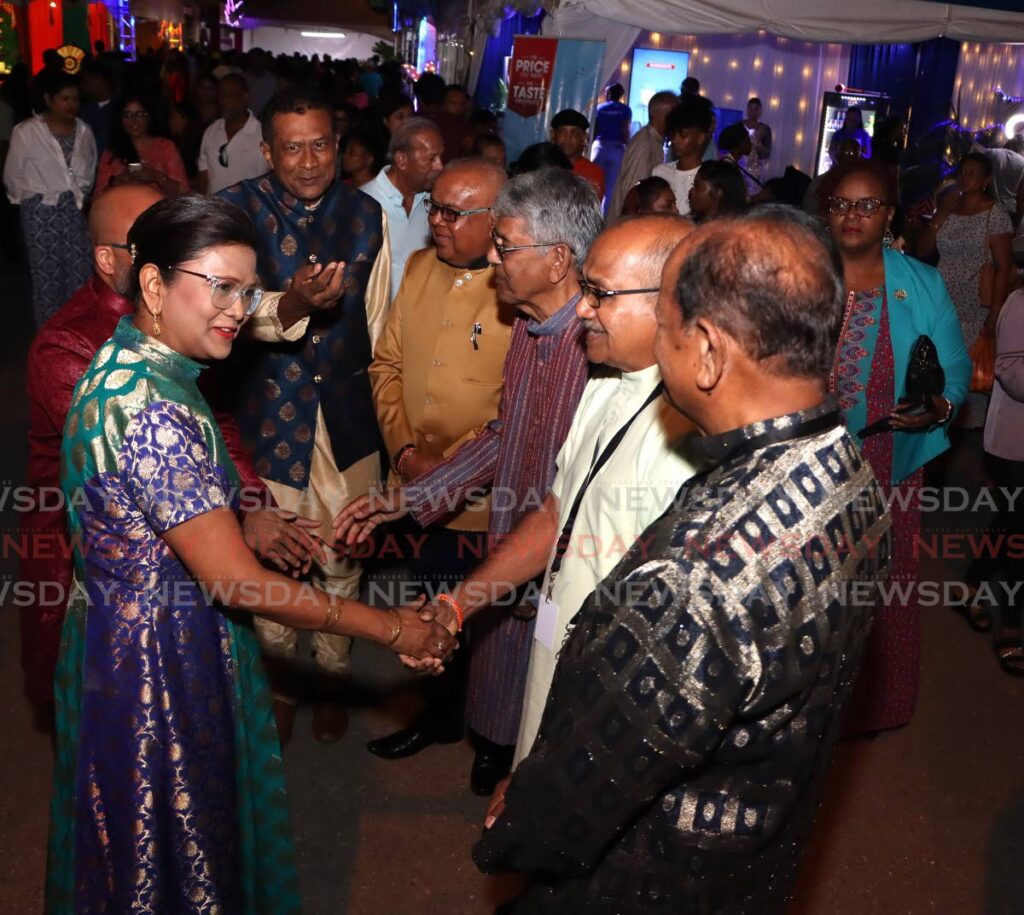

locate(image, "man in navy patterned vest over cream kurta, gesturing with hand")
[[219, 89, 390, 744]]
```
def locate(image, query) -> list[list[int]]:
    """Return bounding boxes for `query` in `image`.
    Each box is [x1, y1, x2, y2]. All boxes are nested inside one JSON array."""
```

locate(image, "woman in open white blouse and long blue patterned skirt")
[[3, 73, 95, 328]]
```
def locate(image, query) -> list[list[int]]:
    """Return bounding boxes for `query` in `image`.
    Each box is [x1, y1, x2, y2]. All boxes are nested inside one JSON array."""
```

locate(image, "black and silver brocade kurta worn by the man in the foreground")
[[474, 402, 890, 915]]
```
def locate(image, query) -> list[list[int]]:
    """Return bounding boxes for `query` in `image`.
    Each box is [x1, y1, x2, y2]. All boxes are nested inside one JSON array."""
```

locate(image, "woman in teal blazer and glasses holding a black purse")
[[821, 160, 971, 733]]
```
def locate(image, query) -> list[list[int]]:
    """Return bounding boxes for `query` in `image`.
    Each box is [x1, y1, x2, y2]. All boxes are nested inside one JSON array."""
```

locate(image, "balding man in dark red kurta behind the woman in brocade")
[[20, 184, 318, 727]]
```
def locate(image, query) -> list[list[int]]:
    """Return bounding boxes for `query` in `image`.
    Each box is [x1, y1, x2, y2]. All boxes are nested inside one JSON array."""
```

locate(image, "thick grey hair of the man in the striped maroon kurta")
[[494, 168, 604, 268]]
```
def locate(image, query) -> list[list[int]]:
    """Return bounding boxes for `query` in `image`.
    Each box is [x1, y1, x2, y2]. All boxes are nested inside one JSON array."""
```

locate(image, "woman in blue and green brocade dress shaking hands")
[[46, 197, 450, 915]]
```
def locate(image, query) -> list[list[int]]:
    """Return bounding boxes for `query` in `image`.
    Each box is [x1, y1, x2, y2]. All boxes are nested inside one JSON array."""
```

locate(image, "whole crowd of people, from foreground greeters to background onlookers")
[[3, 39, 1024, 913]]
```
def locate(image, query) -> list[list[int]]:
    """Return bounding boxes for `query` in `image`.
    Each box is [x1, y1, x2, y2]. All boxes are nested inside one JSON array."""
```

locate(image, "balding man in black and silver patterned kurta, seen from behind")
[[473, 207, 889, 915]]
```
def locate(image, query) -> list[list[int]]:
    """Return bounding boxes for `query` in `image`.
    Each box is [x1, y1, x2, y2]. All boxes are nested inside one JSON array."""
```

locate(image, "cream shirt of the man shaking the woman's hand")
[[516, 365, 694, 761]]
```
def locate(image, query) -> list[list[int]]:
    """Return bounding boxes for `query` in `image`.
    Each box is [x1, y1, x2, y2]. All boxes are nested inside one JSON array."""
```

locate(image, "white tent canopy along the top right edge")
[[544, 0, 1024, 80]]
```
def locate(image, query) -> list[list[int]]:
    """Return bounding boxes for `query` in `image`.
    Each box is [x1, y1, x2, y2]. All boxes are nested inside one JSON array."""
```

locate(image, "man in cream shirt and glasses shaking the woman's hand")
[[411, 210, 694, 761]]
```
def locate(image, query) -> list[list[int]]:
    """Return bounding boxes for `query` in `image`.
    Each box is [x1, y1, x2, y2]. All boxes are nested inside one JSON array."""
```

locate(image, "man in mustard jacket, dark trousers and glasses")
[[368, 160, 514, 759]]
